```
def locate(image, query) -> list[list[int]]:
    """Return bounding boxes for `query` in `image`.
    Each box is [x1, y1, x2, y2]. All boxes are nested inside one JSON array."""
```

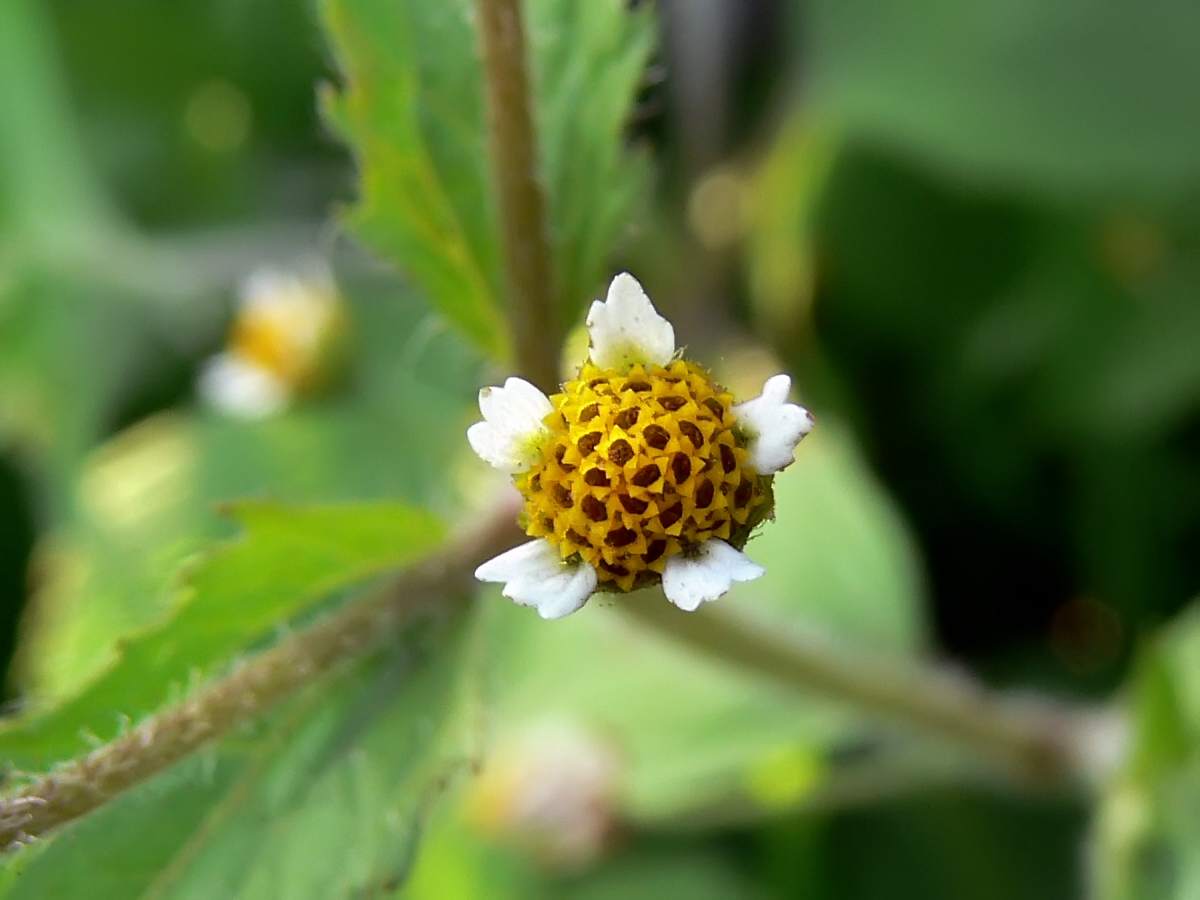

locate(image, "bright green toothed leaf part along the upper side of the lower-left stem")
[[0, 503, 442, 768]]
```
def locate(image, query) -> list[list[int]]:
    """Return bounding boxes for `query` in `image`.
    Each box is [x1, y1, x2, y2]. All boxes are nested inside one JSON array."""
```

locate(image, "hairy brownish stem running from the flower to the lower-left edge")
[[0, 503, 521, 847]]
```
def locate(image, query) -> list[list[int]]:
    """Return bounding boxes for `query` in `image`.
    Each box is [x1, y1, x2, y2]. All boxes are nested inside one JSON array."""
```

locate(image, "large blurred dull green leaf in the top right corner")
[[805, 0, 1200, 196]]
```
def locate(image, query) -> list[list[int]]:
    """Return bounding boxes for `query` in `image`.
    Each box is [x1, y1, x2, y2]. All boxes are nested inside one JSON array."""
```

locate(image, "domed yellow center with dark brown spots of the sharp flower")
[[517, 360, 764, 590]]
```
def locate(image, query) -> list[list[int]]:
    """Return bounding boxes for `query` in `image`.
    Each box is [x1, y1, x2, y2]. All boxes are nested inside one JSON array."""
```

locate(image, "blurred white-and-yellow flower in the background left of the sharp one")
[[197, 263, 344, 419]]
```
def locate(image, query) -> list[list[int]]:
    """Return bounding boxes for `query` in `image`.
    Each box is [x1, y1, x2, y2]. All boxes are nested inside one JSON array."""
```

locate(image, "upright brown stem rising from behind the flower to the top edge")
[[478, 0, 563, 391]]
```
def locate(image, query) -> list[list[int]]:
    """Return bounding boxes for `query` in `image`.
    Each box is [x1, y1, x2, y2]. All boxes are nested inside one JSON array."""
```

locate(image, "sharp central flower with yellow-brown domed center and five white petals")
[[467, 274, 814, 619]]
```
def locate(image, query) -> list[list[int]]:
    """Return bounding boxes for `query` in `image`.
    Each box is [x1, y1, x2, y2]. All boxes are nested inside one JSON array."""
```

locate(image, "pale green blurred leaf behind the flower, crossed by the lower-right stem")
[[491, 419, 923, 820]]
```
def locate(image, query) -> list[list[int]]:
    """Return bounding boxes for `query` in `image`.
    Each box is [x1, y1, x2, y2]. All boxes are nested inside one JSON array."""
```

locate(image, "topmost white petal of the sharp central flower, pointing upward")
[[588, 272, 674, 368]]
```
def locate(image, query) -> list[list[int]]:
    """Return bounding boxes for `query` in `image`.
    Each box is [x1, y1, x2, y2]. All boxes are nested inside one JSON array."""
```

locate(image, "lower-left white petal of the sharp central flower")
[[475, 538, 596, 619]]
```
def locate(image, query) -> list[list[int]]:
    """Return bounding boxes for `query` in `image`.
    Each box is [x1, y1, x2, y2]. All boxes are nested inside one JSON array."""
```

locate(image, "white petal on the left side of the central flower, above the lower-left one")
[[467, 378, 554, 473]]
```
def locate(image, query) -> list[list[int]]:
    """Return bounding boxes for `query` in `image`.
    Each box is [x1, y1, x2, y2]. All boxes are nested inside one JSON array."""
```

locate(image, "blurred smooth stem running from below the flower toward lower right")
[[620, 598, 1124, 787]]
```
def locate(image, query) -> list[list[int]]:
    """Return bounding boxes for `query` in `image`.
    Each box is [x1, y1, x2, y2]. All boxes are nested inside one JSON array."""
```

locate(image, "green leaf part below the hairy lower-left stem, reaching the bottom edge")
[[8, 602, 480, 900]]
